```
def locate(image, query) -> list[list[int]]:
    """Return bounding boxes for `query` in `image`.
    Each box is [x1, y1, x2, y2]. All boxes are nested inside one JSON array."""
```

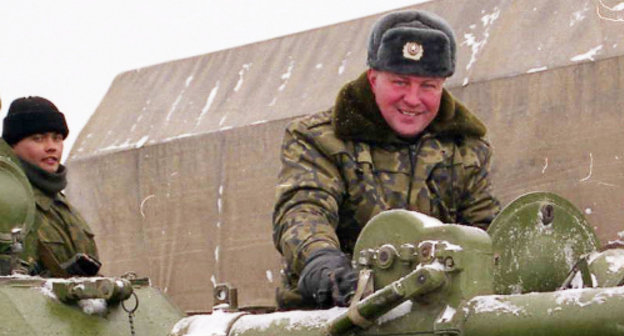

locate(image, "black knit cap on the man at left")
[[2, 96, 69, 146]]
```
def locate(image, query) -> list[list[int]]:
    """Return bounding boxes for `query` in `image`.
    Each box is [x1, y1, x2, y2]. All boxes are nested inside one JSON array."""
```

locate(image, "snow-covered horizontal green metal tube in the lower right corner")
[[457, 287, 624, 336]]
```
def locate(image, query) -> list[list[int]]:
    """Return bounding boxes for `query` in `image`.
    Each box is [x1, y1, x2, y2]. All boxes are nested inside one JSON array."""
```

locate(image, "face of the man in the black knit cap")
[[13, 132, 63, 173]]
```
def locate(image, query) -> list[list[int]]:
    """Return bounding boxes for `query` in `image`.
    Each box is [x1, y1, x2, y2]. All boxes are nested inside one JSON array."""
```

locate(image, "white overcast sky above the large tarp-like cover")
[[0, 0, 427, 157]]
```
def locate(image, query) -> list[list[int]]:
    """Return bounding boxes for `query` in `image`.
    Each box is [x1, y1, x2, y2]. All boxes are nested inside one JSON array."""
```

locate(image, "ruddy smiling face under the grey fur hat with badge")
[[367, 69, 445, 138]]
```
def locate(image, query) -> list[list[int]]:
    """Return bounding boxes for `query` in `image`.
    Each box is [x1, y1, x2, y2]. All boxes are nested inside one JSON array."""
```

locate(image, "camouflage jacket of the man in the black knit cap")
[[22, 175, 99, 277]]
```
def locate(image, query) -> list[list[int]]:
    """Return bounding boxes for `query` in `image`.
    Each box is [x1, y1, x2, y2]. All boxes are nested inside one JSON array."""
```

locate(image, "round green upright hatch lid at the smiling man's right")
[[488, 192, 600, 294]]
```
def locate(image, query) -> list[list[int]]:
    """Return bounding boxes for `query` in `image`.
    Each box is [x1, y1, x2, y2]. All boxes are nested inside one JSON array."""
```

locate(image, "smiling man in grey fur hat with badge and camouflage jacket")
[[273, 11, 500, 309]]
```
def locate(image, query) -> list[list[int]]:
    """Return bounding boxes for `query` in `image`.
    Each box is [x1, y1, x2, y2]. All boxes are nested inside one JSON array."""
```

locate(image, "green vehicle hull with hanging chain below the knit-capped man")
[[0, 276, 184, 336]]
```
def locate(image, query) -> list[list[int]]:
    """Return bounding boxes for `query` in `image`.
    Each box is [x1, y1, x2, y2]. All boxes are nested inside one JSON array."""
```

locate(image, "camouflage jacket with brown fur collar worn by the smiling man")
[[273, 74, 500, 305]]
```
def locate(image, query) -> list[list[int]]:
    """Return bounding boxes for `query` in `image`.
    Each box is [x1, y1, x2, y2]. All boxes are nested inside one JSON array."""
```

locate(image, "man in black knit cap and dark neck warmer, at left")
[[2, 97, 100, 277]]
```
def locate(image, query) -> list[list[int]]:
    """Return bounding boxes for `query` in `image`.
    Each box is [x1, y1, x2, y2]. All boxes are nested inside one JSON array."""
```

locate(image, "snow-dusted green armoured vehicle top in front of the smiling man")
[[170, 192, 624, 336]]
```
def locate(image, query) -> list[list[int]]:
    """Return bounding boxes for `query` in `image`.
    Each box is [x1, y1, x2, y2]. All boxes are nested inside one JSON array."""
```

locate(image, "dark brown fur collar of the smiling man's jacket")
[[332, 72, 486, 143]]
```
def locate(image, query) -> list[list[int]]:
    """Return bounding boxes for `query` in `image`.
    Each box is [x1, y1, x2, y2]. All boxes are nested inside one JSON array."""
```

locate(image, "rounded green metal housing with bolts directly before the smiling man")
[[353, 210, 493, 298]]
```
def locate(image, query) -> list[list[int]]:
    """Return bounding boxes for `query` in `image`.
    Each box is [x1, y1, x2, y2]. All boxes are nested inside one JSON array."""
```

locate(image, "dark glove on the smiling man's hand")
[[297, 248, 358, 308]]
